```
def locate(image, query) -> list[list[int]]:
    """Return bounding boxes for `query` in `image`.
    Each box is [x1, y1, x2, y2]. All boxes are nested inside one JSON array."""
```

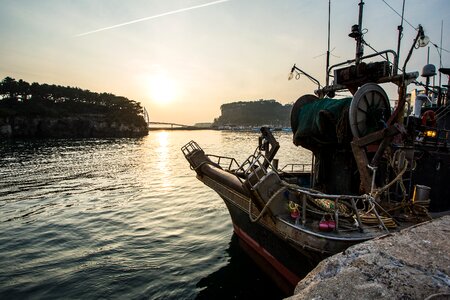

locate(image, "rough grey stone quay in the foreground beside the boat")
[[288, 216, 450, 300]]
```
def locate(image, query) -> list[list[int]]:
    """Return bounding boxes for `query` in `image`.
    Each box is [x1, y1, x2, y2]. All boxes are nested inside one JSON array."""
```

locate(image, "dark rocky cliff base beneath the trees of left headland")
[[0, 115, 148, 138]]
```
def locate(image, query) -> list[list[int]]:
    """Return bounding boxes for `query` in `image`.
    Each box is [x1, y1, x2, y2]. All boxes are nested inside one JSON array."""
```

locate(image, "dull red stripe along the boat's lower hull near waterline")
[[233, 224, 301, 287]]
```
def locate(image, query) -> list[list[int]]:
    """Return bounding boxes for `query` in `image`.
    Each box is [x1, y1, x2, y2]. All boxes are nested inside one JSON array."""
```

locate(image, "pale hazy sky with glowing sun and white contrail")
[[0, 0, 450, 125]]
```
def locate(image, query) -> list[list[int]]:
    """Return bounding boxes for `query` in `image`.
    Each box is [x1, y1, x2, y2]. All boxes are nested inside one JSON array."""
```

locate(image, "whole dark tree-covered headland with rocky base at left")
[[0, 77, 148, 138]]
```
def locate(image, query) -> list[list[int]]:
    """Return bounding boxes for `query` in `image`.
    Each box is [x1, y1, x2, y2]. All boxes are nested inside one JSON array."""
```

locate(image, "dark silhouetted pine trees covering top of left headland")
[[0, 77, 145, 126]]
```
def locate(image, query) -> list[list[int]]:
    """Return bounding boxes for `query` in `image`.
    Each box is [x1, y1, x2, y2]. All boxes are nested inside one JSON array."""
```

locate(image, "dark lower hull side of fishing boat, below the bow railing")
[[198, 172, 376, 294]]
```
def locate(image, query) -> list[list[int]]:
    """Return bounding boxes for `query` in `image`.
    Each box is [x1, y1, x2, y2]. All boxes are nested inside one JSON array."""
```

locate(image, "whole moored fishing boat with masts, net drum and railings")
[[181, 1, 450, 291]]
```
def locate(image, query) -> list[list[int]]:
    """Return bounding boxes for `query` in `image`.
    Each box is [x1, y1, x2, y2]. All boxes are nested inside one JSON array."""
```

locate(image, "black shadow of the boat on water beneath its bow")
[[196, 234, 286, 299]]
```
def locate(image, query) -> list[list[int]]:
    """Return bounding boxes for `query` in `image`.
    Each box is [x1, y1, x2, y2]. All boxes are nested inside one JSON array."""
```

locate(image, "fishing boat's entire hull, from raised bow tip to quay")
[[181, 144, 396, 294]]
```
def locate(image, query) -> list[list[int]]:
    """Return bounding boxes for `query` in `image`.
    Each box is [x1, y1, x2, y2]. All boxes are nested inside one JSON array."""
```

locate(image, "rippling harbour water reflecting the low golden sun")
[[0, 130, 310, 299]]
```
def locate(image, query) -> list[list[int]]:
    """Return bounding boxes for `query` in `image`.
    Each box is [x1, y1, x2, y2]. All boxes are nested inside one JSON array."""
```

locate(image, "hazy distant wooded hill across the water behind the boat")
[[213, 99, 292, 127]]
